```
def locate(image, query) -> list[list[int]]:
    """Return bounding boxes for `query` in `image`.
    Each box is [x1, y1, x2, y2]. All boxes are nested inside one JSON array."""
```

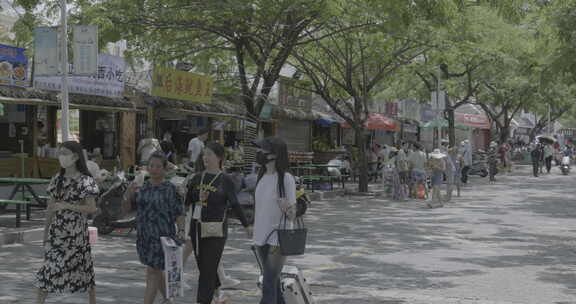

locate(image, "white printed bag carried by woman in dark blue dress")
[[160, 236, 184, 299]]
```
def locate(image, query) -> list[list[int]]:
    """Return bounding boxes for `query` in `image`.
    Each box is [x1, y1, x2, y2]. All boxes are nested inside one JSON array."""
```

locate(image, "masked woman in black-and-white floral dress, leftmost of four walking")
[[35, 141, 99, 304]]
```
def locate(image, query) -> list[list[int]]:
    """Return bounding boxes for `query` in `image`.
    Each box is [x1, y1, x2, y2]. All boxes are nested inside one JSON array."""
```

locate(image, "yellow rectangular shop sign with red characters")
[[152, 67, 212, 103]]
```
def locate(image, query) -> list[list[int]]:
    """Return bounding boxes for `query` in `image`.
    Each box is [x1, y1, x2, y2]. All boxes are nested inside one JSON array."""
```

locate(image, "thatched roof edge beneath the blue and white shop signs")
[[0, 86, 134, 108]]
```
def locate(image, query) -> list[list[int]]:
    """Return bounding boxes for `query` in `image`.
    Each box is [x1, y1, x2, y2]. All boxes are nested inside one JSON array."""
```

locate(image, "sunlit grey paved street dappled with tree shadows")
[[0, 167, 576, 304]]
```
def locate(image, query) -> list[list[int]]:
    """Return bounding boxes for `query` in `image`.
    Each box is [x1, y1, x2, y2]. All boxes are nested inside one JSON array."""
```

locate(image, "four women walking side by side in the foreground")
[[35, 134, 296, 304]]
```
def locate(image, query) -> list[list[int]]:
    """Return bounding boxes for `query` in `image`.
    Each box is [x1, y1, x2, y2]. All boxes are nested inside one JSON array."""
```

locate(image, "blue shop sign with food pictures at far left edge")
[[0, 44, 30, 87]]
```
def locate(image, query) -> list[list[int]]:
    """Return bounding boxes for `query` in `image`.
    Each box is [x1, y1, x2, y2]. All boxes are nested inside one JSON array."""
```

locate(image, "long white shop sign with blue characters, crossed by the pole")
[[34, 54, 125, 98]]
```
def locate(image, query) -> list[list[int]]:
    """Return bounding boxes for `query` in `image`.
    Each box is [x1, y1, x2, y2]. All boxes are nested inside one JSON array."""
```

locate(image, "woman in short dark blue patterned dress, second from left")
[[124, 152, 185, 304]]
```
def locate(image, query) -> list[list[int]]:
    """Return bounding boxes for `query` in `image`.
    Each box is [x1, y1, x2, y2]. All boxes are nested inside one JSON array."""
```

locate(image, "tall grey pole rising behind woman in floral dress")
[[60, 0, 70, 142]]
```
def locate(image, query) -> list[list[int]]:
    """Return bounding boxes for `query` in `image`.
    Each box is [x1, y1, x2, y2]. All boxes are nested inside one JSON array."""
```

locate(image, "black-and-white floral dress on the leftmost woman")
[[35, 174, 99, 293]]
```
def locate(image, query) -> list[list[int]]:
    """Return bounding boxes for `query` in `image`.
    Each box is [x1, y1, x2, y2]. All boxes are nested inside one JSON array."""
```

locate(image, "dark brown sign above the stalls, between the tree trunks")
[[278, 77, 312, 111]]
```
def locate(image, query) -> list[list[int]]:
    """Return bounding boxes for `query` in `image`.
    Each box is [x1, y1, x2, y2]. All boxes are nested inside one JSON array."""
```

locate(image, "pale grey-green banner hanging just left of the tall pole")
[[34, 26, 60, 76]]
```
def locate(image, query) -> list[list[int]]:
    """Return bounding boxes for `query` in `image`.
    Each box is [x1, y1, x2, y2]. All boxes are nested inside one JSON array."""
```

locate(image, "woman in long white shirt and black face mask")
[[254, 137, 296, 304]]
